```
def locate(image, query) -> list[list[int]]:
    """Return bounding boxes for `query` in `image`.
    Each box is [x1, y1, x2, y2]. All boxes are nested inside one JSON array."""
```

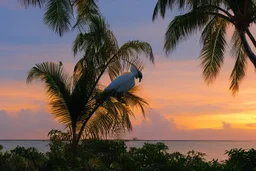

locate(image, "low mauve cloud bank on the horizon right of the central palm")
[[126, 112, 255, 140]]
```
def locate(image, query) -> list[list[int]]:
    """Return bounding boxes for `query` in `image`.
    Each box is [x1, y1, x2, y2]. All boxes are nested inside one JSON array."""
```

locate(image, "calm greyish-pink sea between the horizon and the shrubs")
[[0, 140, 256, 160]]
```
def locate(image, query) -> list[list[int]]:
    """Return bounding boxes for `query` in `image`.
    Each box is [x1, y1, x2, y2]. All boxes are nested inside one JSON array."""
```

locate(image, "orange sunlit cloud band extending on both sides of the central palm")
[[0, 54, 256, 138]]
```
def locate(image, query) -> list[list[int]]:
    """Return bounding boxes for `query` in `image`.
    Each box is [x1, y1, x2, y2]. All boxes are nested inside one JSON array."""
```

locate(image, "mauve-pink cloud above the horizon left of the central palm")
[[0, 109, 64, 139]]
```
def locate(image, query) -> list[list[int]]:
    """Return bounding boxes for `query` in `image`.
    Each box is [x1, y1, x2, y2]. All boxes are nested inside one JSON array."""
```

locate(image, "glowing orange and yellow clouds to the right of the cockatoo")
[[126, 56, 256, 134]]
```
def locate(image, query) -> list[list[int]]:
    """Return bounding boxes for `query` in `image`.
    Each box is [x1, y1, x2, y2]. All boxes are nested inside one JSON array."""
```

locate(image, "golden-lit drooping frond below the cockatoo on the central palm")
[[76, 86, 148, 138]]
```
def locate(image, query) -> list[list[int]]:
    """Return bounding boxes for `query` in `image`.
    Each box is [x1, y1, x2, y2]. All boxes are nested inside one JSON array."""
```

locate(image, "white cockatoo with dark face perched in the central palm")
[[104, 65, 143, 93]]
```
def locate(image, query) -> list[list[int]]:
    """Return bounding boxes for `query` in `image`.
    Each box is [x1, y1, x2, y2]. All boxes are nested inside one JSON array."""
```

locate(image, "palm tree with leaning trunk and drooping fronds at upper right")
[[153, 0, 256, 94]]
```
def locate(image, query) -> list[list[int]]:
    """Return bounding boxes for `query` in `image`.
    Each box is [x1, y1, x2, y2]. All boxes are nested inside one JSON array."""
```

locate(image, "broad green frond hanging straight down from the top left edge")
[[44, 0, 73, 36]]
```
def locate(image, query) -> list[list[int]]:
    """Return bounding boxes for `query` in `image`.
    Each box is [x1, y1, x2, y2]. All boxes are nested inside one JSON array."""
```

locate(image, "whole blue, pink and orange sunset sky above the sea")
[[0, 0, 256, 140]]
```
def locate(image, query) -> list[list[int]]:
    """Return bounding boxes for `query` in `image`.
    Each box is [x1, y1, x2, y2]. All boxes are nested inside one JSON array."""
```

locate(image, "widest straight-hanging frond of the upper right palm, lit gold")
[[200, 17, 227, 84]]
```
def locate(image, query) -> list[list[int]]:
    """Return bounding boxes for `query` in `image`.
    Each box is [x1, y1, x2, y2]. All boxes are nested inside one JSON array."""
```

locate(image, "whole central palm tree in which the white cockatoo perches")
[[27, 17, 154, 148]]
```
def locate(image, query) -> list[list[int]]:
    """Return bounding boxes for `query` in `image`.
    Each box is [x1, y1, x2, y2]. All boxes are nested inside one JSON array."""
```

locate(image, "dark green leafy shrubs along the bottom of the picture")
[[0, 138, 256, 171]]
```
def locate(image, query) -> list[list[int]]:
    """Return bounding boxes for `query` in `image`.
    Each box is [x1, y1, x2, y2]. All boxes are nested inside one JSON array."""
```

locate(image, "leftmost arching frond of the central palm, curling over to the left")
[[27, 62, 72, 124]]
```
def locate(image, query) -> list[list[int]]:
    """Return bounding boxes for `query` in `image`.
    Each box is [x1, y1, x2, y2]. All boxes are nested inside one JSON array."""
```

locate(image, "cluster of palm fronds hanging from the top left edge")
[[19, 0, 99, 36]]
